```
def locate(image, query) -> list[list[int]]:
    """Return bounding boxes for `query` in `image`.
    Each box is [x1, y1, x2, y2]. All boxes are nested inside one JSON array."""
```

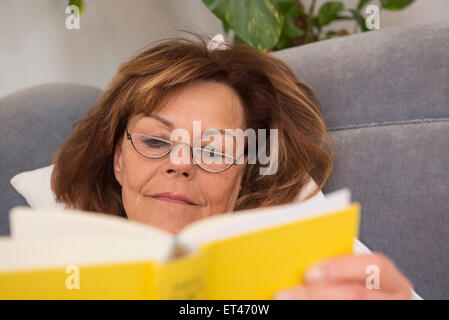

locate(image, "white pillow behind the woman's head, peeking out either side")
[[10, 165, 324, 209]]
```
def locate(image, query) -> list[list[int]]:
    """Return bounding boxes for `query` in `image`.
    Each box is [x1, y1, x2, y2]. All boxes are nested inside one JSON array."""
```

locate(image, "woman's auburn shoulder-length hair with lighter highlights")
[[51, 33, 334, 217]]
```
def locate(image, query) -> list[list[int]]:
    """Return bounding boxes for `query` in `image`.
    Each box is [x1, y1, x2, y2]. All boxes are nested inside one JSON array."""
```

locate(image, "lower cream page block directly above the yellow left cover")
[[0, 236, 172, 272]]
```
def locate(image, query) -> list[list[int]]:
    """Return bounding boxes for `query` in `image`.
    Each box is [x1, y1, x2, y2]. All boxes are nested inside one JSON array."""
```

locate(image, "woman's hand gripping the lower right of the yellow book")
[[274, 252, 412, 300]]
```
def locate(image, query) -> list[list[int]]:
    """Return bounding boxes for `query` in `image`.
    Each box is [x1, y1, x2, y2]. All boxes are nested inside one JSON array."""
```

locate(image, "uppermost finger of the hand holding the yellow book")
[[304, 253, 411, 290]]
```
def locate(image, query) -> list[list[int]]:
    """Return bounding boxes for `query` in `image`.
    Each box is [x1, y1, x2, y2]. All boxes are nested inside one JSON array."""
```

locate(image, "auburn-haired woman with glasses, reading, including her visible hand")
[[52, 33, 411, 299]]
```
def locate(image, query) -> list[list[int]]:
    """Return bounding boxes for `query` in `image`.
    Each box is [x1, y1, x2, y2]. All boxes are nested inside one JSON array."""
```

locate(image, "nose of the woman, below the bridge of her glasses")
[[162, 143, 195, 179]]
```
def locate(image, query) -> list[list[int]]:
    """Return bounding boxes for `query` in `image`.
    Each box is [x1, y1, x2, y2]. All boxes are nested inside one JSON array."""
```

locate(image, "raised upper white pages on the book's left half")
[[10, 207, 175, 261]]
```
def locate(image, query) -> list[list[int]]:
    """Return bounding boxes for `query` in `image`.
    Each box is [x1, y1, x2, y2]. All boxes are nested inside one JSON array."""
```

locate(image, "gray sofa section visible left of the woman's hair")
[[0, 83, 101, 235]]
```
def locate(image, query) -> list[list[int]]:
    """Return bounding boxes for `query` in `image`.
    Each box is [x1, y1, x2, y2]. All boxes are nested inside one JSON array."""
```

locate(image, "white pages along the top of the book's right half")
[[178, 188, 351, 250]]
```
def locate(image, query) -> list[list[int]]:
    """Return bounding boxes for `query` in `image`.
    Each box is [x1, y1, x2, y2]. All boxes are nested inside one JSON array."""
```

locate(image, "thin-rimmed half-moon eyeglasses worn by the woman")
[[126, 128, 246, 173]]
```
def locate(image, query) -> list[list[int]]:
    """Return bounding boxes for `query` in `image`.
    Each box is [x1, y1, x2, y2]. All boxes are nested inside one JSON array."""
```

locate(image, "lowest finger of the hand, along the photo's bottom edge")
[[275, 283, 411, 300]]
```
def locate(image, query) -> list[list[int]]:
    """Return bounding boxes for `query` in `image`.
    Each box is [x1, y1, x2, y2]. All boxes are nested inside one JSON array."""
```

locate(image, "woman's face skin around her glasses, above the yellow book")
[[114, 81, 246, 233]]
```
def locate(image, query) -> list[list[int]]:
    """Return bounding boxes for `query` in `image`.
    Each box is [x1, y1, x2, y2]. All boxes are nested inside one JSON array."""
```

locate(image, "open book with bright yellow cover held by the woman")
[[0, 189, 360, 299]]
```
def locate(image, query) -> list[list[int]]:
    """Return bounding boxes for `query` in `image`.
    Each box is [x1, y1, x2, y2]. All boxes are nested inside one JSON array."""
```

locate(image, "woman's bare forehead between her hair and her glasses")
[[136, 81, 245, 130]]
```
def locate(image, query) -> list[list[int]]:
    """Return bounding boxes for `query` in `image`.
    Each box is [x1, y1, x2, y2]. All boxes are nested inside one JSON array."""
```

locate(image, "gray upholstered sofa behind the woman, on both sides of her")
[[0, 25, 449, 299]]
